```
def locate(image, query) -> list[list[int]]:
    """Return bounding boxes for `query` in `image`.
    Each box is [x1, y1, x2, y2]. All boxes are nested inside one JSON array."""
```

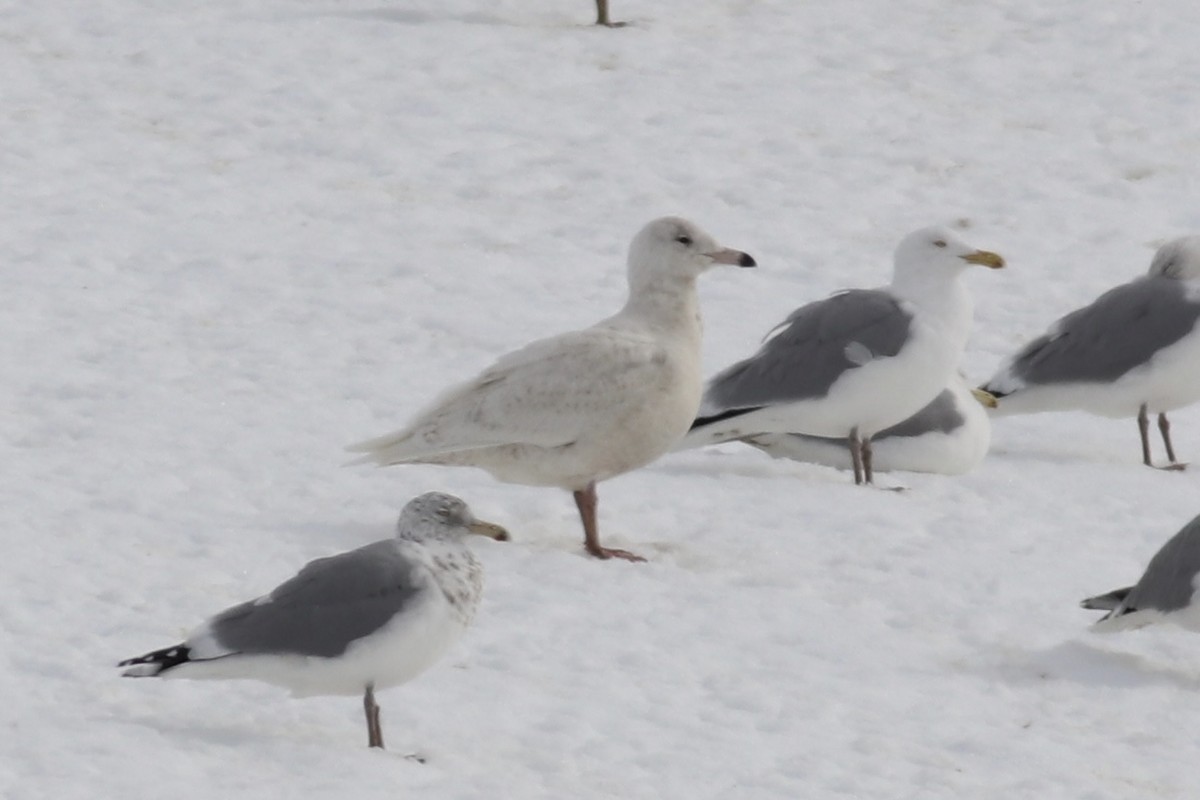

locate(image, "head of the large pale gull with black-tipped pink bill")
[[629, 217, 756, 283]]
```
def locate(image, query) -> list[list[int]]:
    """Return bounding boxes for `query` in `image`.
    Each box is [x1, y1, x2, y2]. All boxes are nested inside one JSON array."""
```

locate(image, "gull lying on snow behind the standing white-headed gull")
[[743, 373, 994, 475]]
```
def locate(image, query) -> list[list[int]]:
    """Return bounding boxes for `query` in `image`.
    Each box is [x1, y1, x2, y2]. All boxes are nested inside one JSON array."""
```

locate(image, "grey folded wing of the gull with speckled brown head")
[[210, 540, 422, 657]]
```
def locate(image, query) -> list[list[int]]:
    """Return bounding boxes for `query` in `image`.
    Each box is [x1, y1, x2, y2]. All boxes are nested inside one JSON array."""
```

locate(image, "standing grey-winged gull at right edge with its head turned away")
[[983, 236, 1200, 470]]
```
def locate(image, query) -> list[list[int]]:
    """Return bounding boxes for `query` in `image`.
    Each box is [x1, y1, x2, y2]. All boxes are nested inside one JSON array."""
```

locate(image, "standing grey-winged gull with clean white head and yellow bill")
[[677, 228, 1004, 483]]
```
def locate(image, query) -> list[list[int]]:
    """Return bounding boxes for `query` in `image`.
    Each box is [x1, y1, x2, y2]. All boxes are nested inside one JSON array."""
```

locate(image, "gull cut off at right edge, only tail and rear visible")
[[1081, 517, 1200, 633]]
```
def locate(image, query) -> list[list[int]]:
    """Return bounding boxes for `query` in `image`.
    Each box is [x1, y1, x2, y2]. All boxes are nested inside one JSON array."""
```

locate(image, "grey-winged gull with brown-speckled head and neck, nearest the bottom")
[[118, 492, 508, 747]]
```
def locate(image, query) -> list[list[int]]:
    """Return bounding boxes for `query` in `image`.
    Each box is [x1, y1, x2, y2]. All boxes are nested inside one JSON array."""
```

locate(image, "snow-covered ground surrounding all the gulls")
[[7, 0, 1200, 800]]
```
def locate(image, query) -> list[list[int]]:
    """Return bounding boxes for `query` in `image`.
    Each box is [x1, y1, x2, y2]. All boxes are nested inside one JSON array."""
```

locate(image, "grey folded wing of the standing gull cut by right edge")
[[985, 277, 1200, 389]]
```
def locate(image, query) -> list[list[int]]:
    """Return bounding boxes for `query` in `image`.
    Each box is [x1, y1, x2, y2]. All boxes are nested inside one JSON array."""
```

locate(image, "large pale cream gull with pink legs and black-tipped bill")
[[349, 217, 755, 561]]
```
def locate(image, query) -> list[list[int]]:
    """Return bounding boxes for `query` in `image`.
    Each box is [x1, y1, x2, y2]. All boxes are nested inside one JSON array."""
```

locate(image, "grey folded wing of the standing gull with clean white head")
[[704, 289, 912, 410]]
